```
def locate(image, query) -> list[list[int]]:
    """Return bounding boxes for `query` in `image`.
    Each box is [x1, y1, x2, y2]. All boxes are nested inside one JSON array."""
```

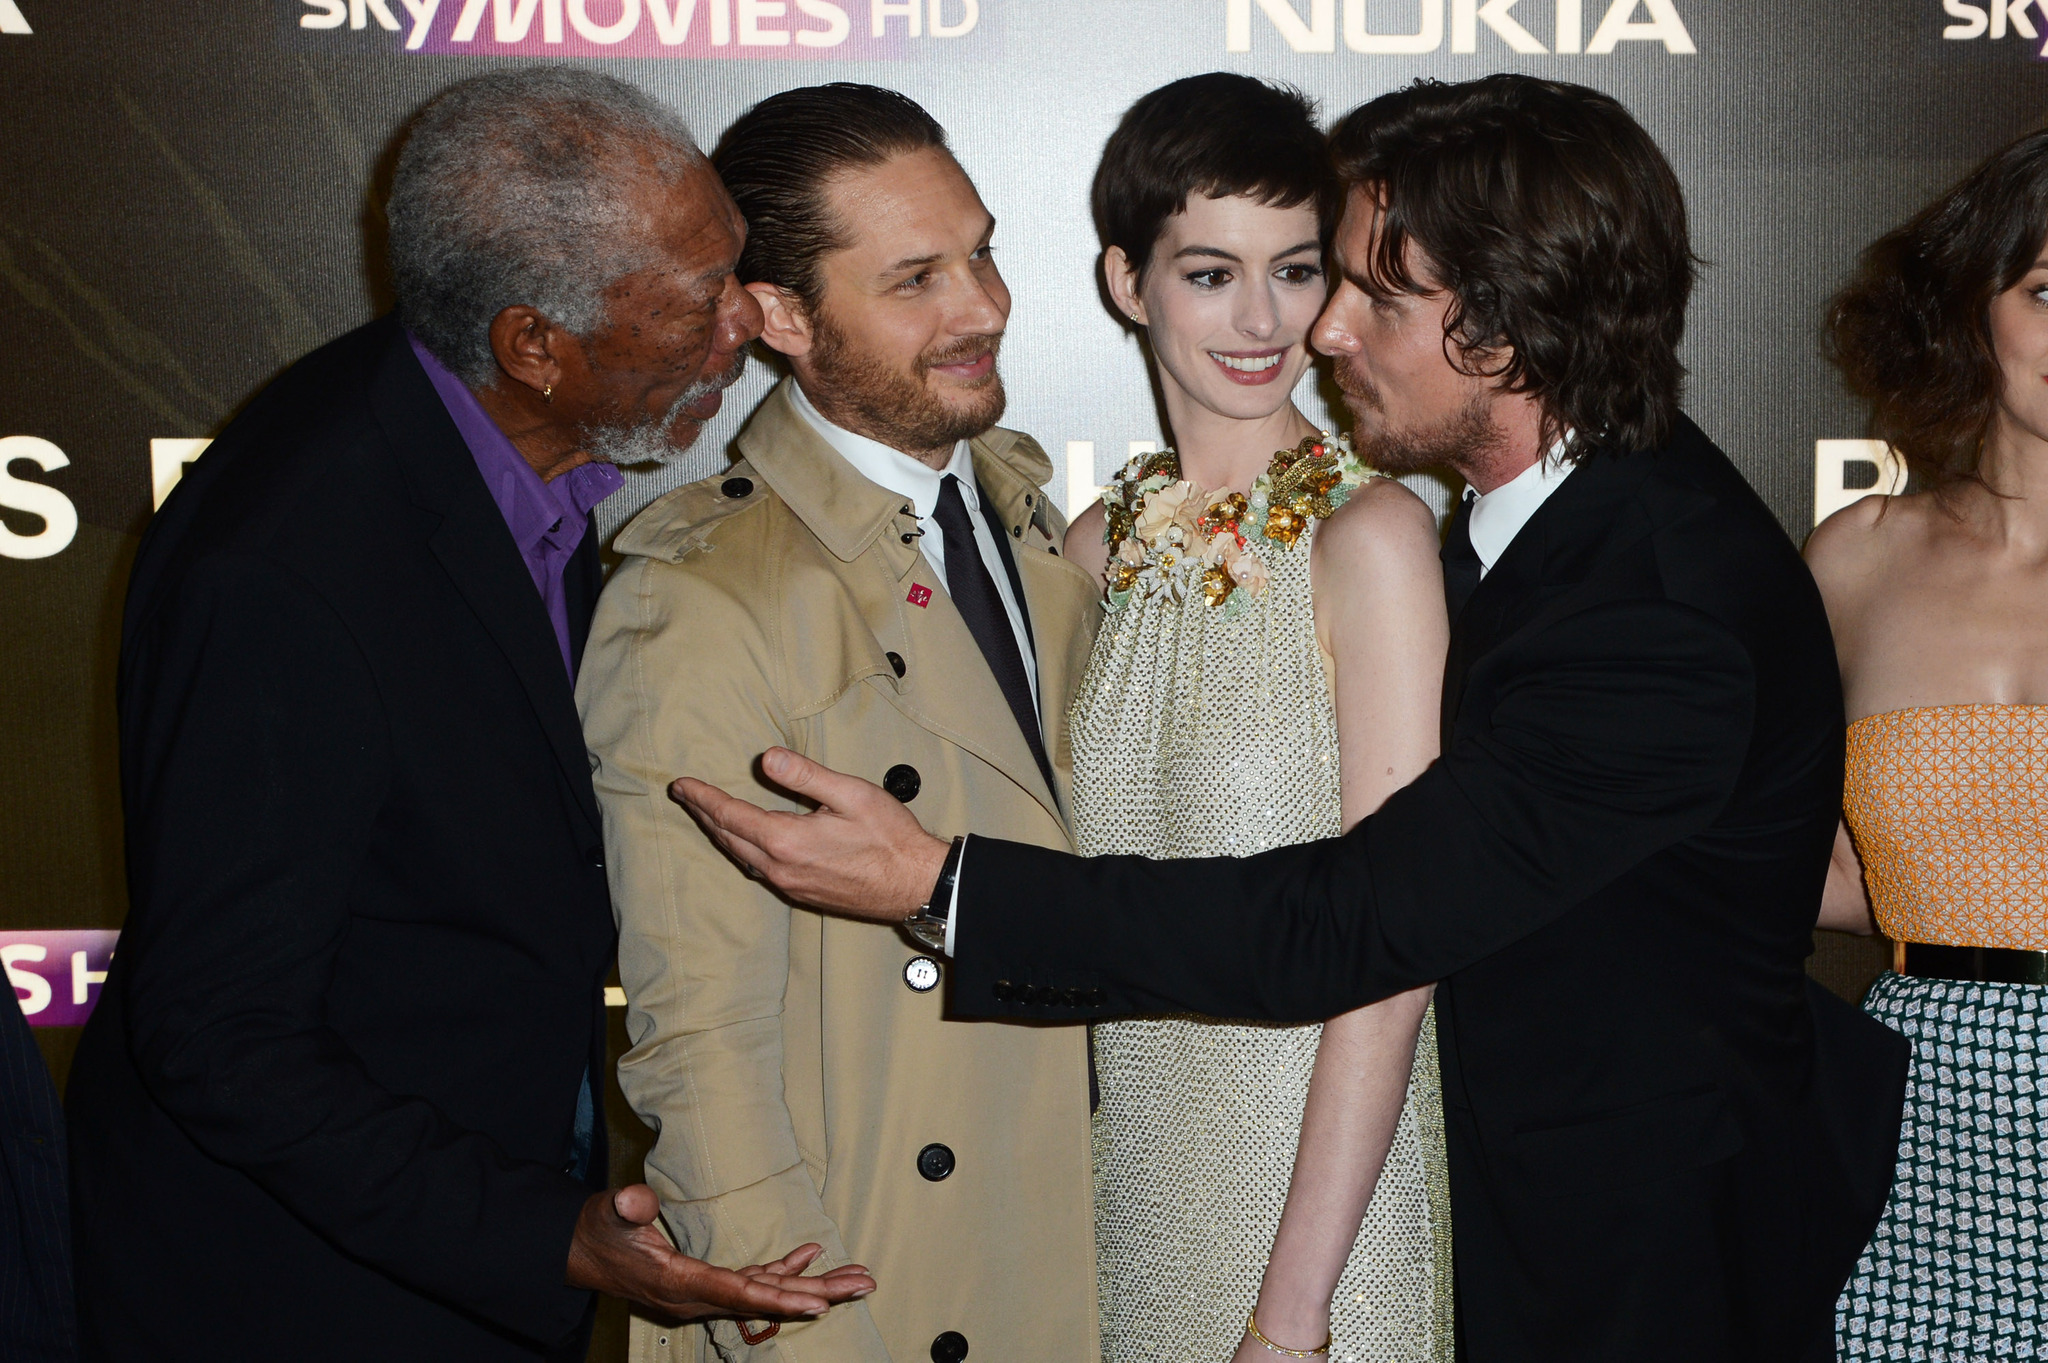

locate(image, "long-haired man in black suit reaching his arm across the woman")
[[676, 76, 1905, 1363]]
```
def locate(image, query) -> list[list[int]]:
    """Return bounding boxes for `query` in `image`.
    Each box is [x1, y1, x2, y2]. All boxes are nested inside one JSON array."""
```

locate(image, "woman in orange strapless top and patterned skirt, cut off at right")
[[1806, 133, 2048, 1363]]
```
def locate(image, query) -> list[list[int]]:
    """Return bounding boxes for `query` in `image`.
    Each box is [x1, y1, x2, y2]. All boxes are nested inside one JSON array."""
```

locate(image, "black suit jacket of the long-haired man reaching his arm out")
[[954, 422, 1905, 1363]]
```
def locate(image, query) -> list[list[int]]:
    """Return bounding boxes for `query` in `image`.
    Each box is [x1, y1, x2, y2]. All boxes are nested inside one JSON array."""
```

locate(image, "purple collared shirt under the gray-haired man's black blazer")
[[406, 332, 625, 682]]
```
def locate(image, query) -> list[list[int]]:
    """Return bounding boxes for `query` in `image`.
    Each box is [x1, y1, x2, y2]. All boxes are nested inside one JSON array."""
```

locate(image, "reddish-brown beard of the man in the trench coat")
[[807, 311, 1008, 452]]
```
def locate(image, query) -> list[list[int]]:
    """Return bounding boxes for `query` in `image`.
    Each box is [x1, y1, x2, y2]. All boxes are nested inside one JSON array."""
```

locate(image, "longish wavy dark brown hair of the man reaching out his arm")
[[1331, 74, 1698, 460]]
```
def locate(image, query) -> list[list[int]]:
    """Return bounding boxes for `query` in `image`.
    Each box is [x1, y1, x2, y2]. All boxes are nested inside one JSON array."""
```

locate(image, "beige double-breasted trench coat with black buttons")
[[578, 378, 1100, 1363]]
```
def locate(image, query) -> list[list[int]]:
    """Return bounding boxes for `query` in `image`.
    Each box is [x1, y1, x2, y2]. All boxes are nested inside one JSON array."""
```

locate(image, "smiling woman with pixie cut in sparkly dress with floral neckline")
[[1067, 74, 1452, 1363]]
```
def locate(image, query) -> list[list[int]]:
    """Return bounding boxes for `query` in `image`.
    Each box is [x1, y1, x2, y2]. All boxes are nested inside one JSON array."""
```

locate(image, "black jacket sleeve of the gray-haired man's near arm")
[[121, 555, 590, 1340]]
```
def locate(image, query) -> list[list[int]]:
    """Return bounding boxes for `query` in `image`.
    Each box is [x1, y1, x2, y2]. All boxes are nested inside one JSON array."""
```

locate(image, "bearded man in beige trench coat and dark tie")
[[580, 86, 1100, 1363]]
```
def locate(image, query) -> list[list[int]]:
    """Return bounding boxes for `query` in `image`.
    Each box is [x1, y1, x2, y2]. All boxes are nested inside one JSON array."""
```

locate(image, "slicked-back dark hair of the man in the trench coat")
[[711, 80, 946, 313]]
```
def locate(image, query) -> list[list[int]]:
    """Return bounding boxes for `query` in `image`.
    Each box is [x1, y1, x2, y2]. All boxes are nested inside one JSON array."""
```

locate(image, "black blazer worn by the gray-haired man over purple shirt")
[[68, 319, 614, 1363]]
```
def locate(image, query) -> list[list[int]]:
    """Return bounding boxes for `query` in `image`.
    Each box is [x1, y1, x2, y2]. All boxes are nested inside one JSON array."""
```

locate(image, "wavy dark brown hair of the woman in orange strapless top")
[[1827, 131, 2048, 493]]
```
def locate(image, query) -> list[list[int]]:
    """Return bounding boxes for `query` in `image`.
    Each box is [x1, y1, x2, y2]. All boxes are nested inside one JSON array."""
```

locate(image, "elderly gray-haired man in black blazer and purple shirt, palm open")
[[70, 68, 874, 1363]]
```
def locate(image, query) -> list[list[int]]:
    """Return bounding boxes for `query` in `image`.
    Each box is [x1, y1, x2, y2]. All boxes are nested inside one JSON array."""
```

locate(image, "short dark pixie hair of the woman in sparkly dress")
[[1094, 72, 1343, 274]]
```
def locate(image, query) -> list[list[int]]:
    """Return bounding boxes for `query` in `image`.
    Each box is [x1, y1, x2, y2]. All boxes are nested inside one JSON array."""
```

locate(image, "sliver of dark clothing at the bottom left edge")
[[0, 980, 78, 1363]]
